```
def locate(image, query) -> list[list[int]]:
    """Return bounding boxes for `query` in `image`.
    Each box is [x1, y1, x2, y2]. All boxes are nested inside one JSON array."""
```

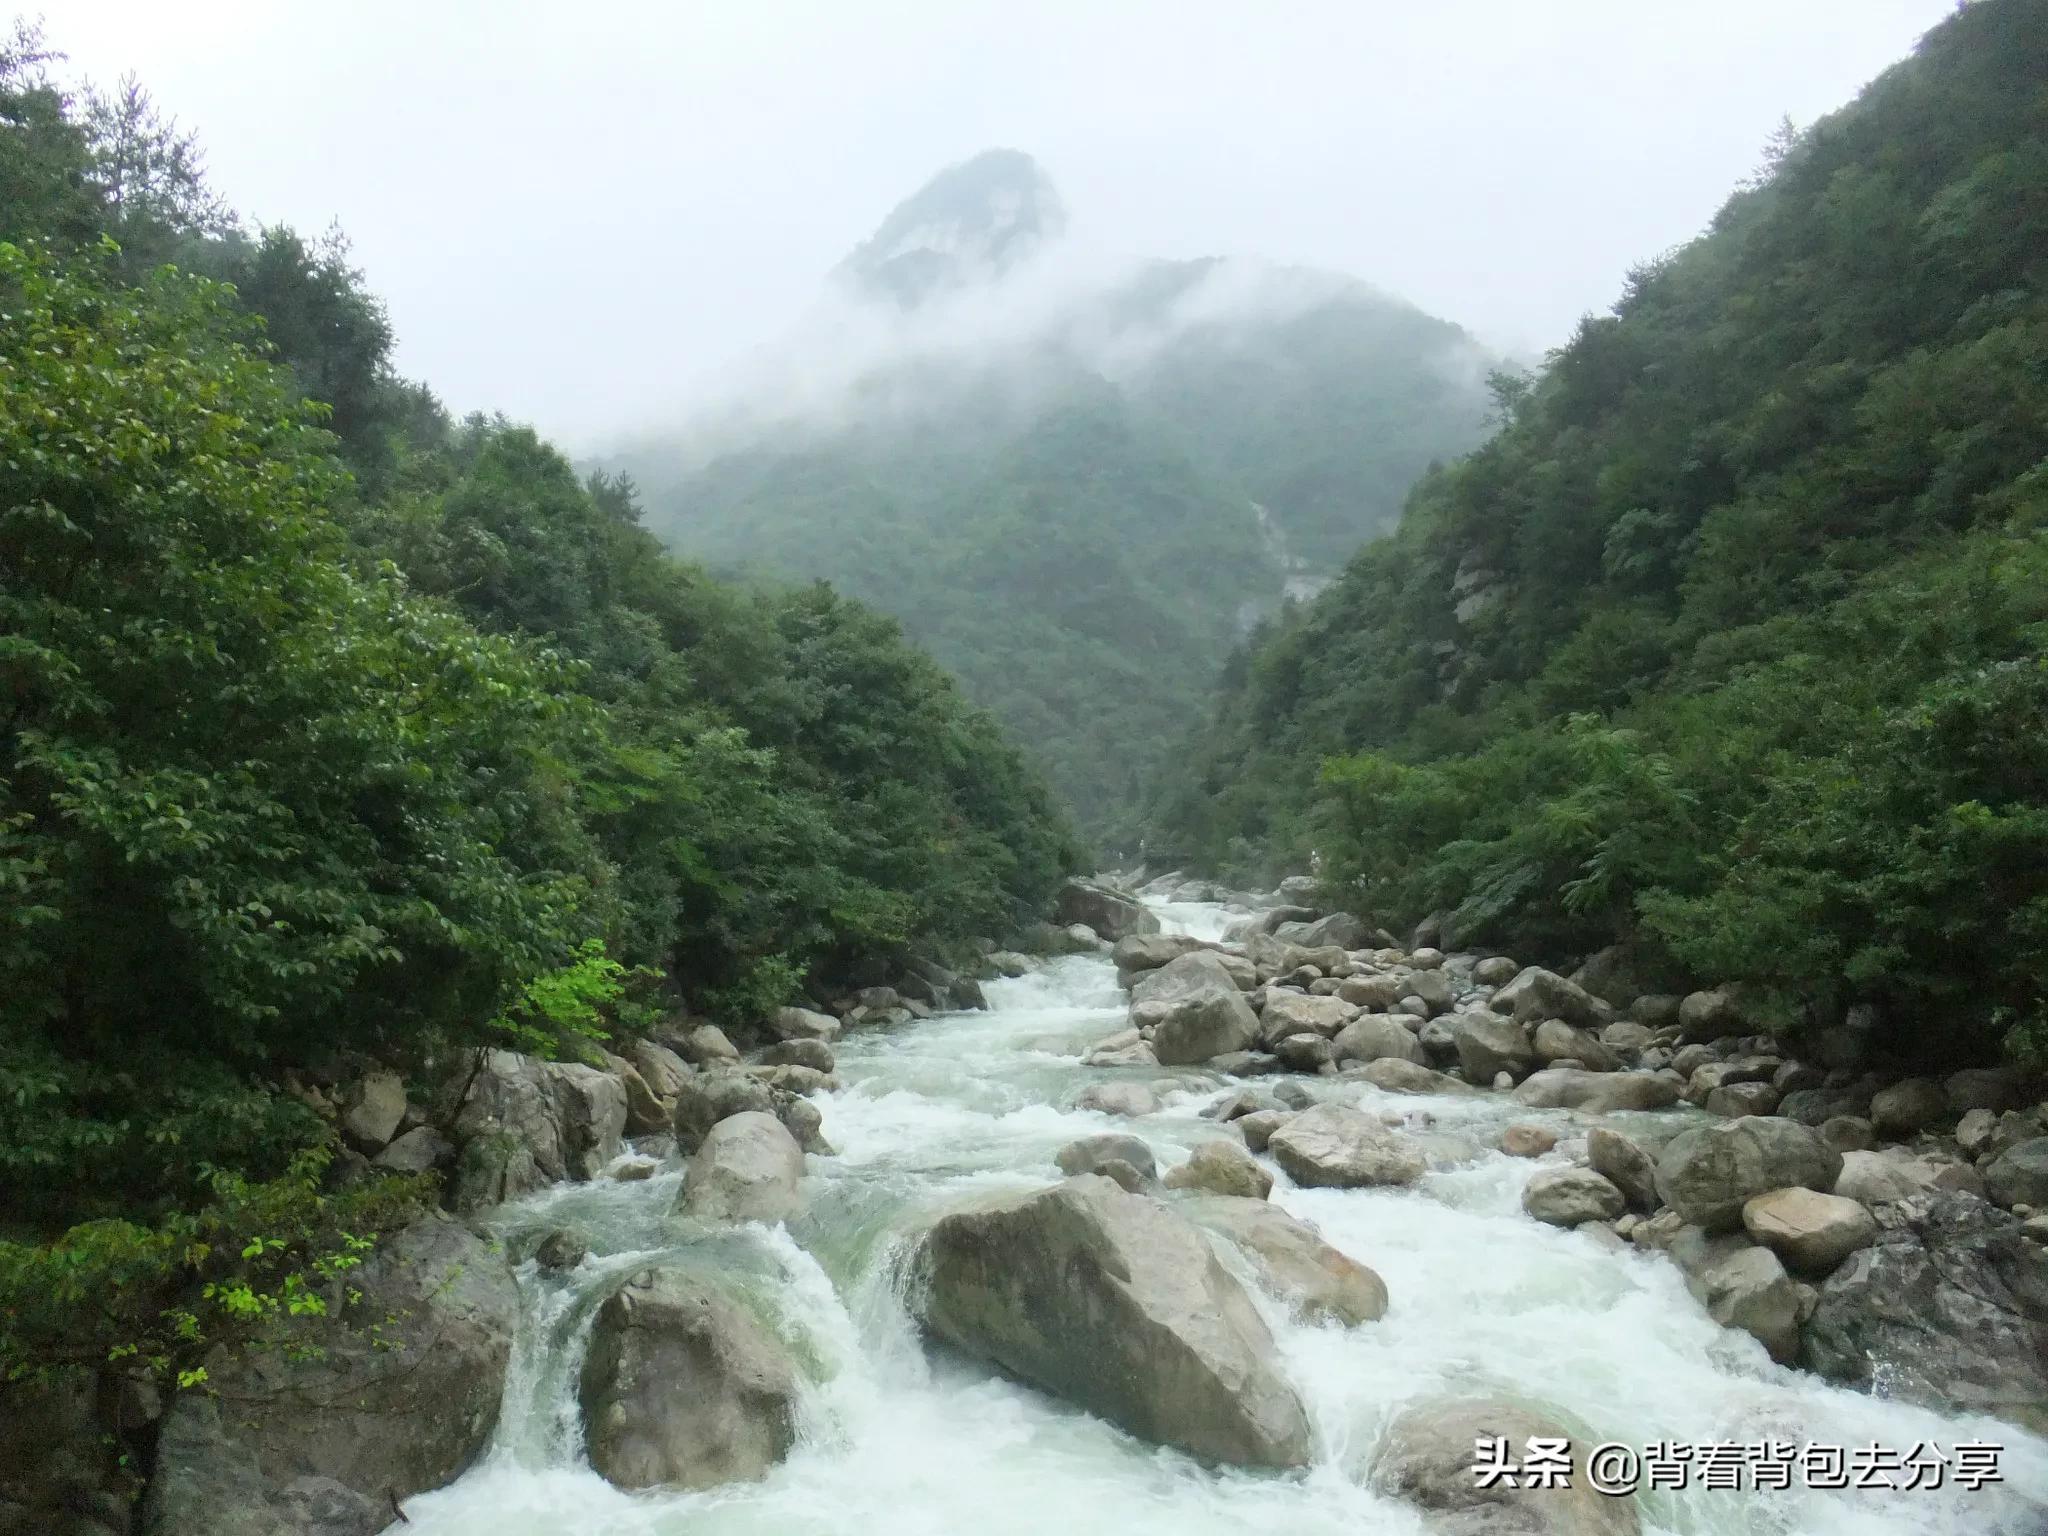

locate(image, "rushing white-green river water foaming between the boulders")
[[391, 905, 2048, 1536]]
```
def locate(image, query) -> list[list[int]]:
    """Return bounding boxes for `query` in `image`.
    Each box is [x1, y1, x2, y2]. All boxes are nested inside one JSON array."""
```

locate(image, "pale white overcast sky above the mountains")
[[56, 0, 1952, 446]]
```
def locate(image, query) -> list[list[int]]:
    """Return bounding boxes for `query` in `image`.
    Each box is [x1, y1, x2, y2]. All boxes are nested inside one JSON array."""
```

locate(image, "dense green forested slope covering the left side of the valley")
[[0, 27, 1075, 1374]]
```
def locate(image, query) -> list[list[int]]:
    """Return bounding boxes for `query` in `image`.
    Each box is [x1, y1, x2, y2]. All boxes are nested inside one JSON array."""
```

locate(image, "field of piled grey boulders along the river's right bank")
[[1087, 874, 2048, 1433]]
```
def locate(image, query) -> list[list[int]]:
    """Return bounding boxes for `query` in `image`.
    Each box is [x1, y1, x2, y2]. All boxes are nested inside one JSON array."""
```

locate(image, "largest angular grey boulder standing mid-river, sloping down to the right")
[[920, 1176, 1311, 1466]]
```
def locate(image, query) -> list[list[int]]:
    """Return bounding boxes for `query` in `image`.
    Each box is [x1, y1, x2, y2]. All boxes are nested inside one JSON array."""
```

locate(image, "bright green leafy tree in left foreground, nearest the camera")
[[0, 246, 604, 1228]]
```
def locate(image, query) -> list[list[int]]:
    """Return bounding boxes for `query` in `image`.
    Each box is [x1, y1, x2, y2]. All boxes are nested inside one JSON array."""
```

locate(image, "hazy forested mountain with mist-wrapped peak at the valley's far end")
[[604, 152, 1487, 848]]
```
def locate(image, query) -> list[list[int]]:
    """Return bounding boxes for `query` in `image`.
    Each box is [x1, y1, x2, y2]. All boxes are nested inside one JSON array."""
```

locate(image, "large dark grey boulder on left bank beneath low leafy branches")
[[143, 1217, 520, 1536]]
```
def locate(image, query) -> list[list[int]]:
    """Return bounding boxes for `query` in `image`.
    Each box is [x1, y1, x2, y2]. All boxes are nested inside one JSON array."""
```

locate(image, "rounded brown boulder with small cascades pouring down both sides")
[[580, 1270, 797, 1489]]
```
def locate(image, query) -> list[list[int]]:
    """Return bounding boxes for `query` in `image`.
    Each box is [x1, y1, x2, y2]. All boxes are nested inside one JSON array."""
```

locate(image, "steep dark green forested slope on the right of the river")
[[1153, 0, 2048, 1059]]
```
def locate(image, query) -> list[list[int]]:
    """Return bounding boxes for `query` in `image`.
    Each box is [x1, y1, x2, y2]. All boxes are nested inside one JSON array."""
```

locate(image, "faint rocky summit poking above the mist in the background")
[[838, 150, 1067, 309]]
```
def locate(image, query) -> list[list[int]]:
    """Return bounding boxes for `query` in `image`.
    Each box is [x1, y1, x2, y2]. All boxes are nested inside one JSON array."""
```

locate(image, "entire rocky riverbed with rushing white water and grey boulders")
[[39, 885, 2048, 1536]]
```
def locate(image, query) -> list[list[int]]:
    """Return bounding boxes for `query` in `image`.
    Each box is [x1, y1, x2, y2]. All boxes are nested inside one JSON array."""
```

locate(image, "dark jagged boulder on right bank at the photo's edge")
[[1804, 1192, 2048, 1434]]
